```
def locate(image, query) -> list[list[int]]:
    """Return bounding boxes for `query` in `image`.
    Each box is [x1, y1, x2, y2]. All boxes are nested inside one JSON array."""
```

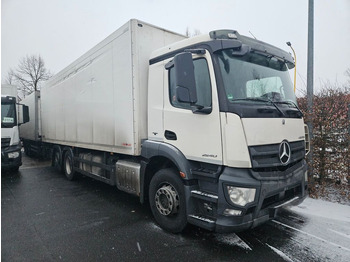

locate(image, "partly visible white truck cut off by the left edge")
[[1, 85, 29, 171]]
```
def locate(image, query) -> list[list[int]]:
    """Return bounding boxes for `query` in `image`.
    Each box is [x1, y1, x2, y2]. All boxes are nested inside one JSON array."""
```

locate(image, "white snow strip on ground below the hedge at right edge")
[[290, 198, 350, 223]]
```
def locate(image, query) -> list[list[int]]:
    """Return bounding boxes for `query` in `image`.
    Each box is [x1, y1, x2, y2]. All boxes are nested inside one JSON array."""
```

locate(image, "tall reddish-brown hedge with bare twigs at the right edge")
[[298, 69, 350, 198]]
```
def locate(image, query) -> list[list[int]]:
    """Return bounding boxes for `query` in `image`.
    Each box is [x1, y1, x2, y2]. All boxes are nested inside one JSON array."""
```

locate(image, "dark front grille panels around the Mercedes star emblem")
[[249, 141, 305, 171]]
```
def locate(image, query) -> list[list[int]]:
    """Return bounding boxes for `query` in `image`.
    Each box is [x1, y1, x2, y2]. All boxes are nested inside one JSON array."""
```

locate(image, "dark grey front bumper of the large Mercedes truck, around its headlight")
[[215, 160, 307, 232]]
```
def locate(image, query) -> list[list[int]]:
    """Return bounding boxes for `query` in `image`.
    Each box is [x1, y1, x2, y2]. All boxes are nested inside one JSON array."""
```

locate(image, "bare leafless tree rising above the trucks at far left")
[[7, 55, 52, 97]]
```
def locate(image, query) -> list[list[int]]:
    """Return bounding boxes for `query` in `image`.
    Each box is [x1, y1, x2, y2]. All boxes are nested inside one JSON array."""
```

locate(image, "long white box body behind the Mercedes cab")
[[41, 20, 185, 155]]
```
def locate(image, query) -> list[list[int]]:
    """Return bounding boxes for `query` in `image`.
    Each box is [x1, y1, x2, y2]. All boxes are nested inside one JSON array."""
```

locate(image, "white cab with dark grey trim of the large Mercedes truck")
[[143, 30, 307, 232]]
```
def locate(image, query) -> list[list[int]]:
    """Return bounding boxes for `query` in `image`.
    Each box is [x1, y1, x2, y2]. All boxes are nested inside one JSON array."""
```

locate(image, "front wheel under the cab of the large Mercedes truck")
[[149, 169, 187, 233]]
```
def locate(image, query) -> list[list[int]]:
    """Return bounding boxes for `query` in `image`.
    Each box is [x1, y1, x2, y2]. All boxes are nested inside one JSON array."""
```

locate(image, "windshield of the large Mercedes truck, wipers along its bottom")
[[217, 49, 297, 107]]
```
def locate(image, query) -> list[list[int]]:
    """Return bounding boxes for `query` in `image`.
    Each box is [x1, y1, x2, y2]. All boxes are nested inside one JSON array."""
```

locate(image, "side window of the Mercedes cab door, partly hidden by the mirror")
[[169, 58, 212, 109]]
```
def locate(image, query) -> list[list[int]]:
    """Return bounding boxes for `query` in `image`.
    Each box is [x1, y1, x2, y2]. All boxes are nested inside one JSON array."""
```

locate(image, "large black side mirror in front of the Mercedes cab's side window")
[[174, 52, 197, 104]]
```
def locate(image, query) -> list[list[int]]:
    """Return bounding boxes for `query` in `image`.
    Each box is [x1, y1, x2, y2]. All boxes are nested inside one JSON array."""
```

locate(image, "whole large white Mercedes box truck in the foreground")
[[19, 19, 308, 232]]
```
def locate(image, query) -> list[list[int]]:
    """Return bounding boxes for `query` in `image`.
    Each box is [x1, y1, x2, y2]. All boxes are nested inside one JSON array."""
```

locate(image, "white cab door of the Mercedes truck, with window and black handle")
[[163, 52, 222, 165]]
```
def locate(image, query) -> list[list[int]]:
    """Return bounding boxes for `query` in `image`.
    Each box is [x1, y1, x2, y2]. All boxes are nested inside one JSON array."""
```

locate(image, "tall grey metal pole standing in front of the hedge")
[[307, 0, 314, 175]]
